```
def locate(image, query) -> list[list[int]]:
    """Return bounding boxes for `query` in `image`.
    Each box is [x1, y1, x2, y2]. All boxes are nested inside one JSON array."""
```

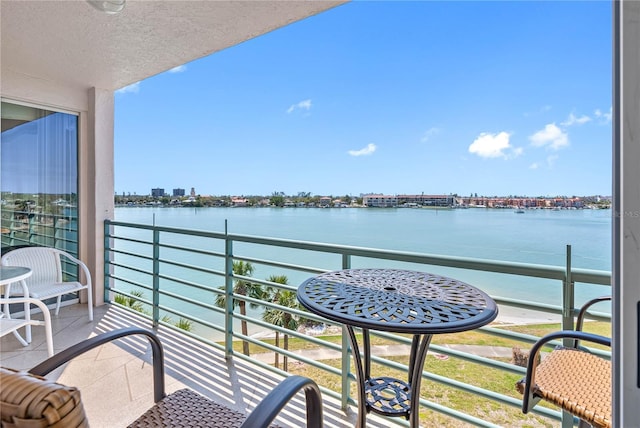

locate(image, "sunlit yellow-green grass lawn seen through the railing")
[[226, 321, 611, 427]]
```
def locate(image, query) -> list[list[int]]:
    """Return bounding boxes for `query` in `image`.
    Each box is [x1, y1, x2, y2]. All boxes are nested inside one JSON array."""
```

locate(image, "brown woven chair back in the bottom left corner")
[[0, 367, 89, 428]]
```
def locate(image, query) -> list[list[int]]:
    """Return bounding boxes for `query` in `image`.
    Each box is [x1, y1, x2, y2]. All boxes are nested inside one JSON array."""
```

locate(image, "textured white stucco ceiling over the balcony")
[[0, 0, 344, 90]]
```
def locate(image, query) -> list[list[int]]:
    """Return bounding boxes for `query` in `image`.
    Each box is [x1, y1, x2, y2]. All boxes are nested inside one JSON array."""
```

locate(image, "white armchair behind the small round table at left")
[[2, 247, 93, 320]]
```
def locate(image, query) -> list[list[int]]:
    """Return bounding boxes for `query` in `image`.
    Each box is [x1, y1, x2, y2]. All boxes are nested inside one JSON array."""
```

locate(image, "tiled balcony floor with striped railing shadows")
[[0, 305, 391, 428]]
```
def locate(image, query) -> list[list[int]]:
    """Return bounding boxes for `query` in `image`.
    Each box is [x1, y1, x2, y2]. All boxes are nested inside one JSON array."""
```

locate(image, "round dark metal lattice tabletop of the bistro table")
[[298, 269, 498, 334]]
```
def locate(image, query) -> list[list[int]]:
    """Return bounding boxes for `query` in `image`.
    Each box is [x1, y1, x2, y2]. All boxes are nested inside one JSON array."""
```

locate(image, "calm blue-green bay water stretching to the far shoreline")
[[115, 207, 612, 334]]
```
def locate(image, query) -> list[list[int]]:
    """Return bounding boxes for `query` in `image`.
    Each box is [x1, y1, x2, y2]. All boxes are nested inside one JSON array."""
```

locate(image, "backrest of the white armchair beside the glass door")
[[2, 247, 62, 286]]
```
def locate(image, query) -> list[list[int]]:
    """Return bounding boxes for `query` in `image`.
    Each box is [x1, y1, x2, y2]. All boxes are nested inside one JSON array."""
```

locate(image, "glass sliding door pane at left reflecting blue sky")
[[0, 102, 78, 256]]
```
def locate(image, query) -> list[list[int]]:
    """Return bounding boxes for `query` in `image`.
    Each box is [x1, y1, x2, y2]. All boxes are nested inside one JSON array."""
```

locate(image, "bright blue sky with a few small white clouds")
[[115, 1, 612, 196]]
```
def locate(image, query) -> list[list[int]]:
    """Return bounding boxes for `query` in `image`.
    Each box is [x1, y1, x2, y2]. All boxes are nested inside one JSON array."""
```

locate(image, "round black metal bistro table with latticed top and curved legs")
[[298, 269, 498, 428]]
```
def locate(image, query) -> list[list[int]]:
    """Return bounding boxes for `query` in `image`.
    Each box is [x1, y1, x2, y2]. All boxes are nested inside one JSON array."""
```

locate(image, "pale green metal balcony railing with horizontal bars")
[[104, 221, 611, 426]]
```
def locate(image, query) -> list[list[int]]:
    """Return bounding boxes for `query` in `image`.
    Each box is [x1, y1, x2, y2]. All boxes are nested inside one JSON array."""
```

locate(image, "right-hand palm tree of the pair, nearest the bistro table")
[[262, 275, 299, 371]]
